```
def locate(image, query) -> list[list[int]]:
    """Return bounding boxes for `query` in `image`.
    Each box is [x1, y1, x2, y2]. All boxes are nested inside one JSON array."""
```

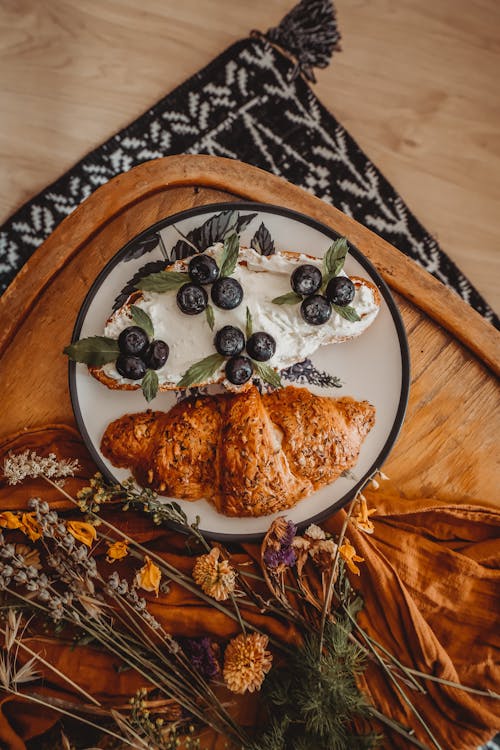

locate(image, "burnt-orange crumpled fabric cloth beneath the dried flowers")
[[0, 426, 500, 750]]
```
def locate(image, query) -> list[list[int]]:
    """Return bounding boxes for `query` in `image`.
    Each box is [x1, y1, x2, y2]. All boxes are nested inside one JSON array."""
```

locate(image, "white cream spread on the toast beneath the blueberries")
[[102, 243, 378, 384]]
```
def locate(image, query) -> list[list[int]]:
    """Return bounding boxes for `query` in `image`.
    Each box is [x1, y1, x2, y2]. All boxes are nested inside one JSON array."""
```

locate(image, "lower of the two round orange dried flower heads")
[[223, 633, 273, 693]]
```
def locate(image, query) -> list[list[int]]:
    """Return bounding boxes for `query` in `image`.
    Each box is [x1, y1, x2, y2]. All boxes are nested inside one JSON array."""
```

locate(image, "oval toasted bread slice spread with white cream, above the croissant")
[[89, 246, 381, 391]]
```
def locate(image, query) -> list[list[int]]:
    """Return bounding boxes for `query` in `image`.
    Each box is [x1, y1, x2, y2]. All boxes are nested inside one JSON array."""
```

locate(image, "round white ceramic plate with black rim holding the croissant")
[[69, 203, 409, 540]]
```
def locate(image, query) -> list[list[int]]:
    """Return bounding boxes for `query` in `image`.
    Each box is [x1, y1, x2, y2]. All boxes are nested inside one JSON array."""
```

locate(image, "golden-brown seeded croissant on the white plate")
[[101, 386, 375, 517]]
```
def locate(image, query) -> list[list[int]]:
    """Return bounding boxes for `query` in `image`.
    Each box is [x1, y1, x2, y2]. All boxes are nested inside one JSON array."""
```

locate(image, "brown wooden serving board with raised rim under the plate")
[[0, 156, 500, 505]]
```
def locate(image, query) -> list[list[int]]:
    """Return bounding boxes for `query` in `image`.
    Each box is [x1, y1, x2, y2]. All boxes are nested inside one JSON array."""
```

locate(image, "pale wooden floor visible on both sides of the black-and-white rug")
[[0, 0, 500, 311]]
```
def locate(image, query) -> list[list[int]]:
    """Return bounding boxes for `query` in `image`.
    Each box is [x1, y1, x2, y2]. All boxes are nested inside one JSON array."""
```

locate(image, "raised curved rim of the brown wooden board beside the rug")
[[0, 155, 500, 376]]
